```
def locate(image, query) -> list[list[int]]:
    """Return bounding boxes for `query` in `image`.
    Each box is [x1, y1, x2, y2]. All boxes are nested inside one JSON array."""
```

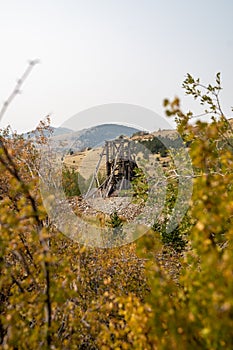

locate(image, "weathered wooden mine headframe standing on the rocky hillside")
[[85, 137, 137, 198]]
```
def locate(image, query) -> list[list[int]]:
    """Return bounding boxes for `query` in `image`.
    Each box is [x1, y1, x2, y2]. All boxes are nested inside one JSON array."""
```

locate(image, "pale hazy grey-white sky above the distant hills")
[[0, 0, 233, 132]]
